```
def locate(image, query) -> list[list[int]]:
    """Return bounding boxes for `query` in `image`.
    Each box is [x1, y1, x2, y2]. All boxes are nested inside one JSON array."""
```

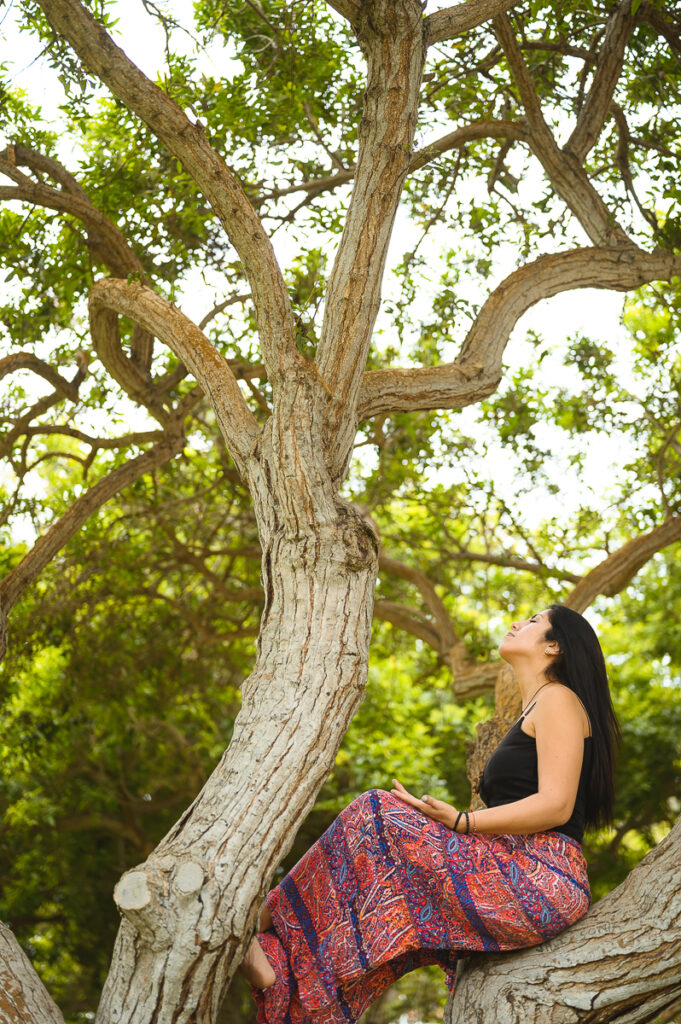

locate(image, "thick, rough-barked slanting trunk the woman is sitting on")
[[444, 818, 681, 1024]]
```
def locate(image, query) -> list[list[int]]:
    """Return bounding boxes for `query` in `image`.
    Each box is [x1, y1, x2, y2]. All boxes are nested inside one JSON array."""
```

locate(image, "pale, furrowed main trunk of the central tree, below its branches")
[[96, 371, 378, 1024]]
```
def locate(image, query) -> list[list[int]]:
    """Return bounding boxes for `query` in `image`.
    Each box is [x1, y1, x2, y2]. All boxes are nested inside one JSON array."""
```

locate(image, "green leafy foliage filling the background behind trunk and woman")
[[0, 0, 681, 1024]]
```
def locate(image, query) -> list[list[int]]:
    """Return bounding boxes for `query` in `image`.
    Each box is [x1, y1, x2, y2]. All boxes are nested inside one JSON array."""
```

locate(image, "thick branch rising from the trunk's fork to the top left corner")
[[33, 0, 301, 384]]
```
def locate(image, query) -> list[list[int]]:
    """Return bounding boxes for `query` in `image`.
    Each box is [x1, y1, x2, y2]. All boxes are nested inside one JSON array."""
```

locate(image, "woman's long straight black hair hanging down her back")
[[546, 604, 622, 828]]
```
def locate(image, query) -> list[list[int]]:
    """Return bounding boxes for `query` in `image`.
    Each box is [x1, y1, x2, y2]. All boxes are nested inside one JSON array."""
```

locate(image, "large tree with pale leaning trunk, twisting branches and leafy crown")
[[0, 0, 681, 1022]]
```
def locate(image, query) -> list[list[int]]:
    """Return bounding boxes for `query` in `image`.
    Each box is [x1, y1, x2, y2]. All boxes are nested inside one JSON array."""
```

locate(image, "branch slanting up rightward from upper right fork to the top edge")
[[563, 0, 634, 164]]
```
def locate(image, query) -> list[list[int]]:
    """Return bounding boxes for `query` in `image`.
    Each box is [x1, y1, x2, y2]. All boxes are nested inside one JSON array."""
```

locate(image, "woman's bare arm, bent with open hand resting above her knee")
[[392, 685, 585, 836]]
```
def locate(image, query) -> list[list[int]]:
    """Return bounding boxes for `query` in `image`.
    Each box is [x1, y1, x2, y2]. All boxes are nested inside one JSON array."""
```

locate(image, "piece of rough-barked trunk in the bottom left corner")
[[0, 923, 63, 1024]]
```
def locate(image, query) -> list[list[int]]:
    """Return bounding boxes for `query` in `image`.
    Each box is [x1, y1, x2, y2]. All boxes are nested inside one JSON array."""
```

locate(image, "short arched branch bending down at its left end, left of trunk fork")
[[90, 279, 260, 471]]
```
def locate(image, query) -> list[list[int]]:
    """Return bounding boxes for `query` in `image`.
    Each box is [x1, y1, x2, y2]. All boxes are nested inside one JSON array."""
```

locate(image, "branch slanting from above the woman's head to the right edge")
[[564, 515, 681, 611]]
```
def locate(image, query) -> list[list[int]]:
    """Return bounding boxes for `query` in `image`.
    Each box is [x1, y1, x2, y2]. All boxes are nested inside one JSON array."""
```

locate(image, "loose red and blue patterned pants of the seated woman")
[[253, 790, 591, 1024]]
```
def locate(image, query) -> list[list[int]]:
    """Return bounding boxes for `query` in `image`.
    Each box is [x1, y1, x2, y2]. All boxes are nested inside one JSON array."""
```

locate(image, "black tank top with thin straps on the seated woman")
[[480, 705, 592, 843]]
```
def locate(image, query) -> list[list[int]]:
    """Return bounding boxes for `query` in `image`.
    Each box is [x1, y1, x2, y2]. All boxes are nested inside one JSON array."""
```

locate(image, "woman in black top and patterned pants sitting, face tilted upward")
[[242, 604, 620, 1024]]
